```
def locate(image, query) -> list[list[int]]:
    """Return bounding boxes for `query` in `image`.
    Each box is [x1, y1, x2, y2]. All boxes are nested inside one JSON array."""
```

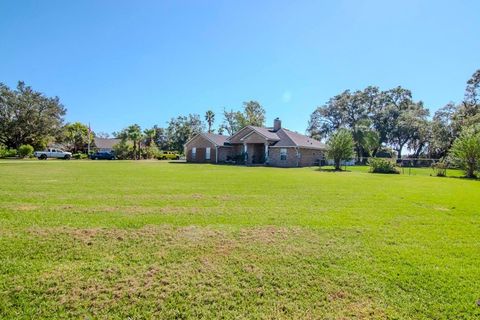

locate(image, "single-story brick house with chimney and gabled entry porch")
[[185, 118, 326, 167]]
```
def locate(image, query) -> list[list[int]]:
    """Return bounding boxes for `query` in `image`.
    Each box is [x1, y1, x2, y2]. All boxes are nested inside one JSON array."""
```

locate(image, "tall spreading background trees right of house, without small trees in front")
[[307, 70, 480, 159]]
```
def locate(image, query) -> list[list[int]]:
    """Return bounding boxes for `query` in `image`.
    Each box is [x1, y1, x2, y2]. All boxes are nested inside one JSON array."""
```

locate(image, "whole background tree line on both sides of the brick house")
[[0, 70, 480, 176]]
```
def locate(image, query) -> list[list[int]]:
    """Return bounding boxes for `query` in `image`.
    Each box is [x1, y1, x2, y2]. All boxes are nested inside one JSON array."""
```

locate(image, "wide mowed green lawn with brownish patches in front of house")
[[0, 160, 480, 319]]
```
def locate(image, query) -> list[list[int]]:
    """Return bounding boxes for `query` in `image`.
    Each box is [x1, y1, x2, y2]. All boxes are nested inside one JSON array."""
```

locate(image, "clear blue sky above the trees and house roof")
[[0, 0, 480, 133]]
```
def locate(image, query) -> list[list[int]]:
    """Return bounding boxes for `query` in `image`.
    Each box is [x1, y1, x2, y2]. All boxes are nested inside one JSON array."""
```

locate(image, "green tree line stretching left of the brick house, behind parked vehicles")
[[0, 81, 265, 159]]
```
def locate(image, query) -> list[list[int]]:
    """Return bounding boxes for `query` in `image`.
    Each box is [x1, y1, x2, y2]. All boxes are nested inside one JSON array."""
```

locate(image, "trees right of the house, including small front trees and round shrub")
[[307, 70, 480, 178]]
